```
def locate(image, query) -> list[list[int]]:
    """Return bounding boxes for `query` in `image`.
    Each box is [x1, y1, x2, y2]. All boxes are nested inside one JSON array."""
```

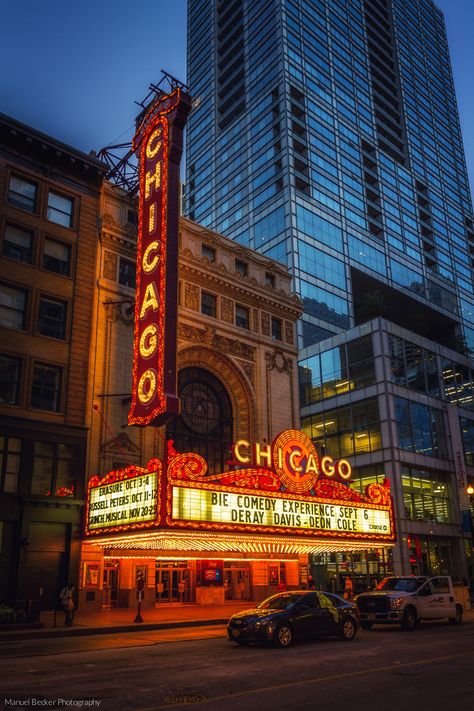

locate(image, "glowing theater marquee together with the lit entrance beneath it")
[[81, 430, 396, 606]]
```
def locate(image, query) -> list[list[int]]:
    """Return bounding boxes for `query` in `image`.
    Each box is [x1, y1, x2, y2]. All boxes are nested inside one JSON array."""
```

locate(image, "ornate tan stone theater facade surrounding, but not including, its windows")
[[88, 192, 301, 484]]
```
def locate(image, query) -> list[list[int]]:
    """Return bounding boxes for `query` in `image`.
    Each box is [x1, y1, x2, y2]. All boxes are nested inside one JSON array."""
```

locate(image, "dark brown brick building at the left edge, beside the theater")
[[0, 115, 105, 607]]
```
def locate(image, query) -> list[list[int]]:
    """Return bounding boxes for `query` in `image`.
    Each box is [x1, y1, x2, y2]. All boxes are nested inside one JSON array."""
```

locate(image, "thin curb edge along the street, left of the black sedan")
[[0, 617, 229, 643]]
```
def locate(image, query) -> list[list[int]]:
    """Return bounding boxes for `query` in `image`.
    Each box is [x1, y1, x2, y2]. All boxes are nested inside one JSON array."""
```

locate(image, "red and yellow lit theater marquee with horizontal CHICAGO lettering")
[[85, 430, 395, 557]]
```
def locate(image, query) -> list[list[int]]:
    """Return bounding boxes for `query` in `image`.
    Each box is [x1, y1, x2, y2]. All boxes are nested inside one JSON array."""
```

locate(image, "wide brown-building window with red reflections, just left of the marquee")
[[31, 442, 77, 497]]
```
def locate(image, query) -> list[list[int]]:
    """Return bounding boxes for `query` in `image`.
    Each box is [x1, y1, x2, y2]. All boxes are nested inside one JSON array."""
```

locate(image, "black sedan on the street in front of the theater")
[[227, 590, 359, 647]]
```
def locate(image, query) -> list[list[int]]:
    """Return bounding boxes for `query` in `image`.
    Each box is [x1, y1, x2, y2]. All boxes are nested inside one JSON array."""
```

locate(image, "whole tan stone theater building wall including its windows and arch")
[[79, 183, 302, 608]]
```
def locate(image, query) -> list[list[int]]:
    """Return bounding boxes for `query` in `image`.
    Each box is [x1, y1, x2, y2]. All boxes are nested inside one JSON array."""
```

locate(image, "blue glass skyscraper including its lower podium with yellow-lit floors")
[[185, 0, 474, 587]]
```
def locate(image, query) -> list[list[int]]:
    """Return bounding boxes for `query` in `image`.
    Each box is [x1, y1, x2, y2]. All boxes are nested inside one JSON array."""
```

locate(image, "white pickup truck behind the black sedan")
[[355, 575, 463, 631]]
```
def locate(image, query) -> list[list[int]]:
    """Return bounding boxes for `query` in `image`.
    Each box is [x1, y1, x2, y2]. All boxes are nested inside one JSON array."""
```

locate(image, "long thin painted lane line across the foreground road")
[[147, 649, 474, 711]]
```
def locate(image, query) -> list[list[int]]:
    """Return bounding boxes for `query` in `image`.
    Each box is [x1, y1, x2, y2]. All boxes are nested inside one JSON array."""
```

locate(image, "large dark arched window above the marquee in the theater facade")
[[166, 368, 233, 473]]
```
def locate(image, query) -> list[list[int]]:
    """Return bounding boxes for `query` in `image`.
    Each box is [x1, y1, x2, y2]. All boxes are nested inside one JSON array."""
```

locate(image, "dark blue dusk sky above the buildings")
[[0, 0, 474, 200]]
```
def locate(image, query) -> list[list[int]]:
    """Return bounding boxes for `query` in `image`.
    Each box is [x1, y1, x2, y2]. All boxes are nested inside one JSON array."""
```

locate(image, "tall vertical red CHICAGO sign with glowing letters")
[[128, 88, 191, 426]]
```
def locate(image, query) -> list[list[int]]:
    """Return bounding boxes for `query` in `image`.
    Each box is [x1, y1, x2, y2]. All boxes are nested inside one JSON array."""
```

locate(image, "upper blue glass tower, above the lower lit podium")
[[186, 0, 474, 350]]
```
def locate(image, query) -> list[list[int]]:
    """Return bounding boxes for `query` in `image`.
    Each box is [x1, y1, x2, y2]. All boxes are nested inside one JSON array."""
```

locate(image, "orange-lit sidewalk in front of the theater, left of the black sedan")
[[0, 600, 255, 642]]
